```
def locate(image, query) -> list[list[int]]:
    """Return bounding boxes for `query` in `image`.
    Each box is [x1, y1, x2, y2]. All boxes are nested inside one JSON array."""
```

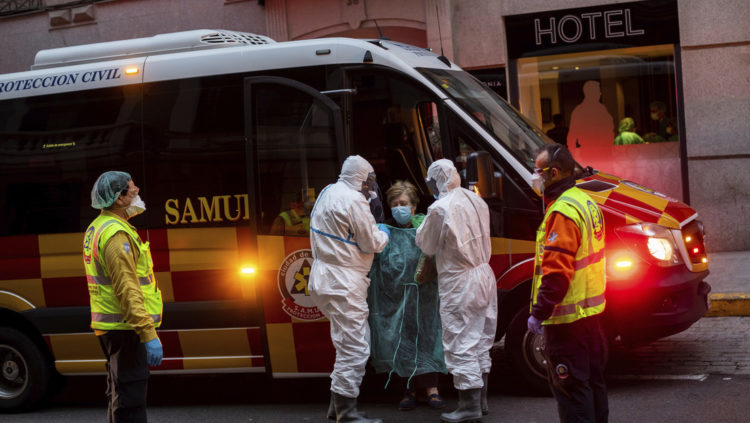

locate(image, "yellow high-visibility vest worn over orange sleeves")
[[531, 187, 606, 324]]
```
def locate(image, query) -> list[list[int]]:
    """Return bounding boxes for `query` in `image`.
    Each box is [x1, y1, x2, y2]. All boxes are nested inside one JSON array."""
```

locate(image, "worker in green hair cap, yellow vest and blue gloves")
[[83, 171, 162, 423]]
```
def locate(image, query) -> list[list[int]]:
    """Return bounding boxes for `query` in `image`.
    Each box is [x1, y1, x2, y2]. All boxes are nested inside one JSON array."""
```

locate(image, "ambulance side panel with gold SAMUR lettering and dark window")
[[142, 75, 266, 373]]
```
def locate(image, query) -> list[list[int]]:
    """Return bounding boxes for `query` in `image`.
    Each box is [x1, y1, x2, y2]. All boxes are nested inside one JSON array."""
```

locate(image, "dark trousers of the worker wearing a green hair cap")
[[98, 330, 149, 423]]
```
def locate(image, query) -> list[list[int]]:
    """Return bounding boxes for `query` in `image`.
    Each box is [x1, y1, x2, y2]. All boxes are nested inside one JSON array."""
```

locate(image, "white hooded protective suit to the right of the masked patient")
[[416, 159, 497, 390]]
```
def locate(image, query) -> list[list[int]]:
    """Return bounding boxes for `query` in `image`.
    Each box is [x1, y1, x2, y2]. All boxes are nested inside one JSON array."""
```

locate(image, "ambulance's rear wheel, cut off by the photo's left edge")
[[0, 327, 52, 412]]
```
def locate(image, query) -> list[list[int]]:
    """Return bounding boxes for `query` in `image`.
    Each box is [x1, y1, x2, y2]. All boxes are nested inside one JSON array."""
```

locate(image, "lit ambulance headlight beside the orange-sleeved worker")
[[616, 223, 682, 266]]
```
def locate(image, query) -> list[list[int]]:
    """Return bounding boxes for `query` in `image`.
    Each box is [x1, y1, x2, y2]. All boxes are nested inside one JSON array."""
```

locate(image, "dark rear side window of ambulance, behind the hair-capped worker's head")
[[0, 86, 143, 236]]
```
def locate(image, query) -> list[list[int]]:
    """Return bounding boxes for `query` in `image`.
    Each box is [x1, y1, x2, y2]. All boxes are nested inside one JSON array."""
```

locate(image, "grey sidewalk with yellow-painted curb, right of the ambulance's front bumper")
[[706, 251, 750, 317]]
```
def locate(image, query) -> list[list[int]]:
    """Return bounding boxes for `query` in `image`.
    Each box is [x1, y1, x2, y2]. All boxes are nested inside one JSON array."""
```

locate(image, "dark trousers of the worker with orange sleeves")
[[544, 315, 609, 423]]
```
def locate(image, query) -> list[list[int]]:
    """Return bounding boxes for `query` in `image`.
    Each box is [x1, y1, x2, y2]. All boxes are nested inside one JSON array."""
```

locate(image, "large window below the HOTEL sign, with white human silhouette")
[[517, 44, 683, 198]]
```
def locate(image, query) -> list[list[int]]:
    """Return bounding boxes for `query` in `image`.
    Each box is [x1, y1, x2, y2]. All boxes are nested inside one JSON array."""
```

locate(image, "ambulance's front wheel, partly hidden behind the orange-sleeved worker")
[[505, 303, 550, 395]]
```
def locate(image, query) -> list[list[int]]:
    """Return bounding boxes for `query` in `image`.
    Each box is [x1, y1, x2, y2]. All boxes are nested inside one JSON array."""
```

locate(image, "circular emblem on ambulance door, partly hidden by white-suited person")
[[277, 250, 323, 320]]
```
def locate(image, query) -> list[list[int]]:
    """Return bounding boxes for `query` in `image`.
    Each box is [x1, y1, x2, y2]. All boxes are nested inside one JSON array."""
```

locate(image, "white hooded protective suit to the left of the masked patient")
[[308, 156, 388, 398]]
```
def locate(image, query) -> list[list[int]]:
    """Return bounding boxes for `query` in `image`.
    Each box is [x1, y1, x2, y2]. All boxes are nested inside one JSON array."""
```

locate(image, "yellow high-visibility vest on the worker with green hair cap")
[[83, 214, 163, 330]]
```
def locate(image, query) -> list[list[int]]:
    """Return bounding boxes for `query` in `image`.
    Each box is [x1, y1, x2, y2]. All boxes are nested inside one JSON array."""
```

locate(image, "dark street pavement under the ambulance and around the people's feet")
[[7, 316, 750, 423]]
